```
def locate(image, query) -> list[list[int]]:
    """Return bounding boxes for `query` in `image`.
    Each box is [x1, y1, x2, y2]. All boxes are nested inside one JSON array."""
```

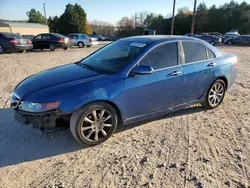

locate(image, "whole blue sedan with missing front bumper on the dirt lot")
[[11, 36, 237, 145]]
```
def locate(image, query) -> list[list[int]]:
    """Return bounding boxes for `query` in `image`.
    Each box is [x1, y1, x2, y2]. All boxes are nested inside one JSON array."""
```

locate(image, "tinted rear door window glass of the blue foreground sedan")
[[182, 41, 207, 63]]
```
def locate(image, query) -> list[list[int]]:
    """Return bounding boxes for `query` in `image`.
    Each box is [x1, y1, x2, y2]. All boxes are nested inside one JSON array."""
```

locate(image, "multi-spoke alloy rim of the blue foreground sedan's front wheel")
[[81, 109, 113, 142]]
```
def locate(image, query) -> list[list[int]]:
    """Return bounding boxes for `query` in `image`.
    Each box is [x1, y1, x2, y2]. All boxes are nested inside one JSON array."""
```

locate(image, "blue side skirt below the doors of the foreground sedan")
[[123, 99, 203, 126]]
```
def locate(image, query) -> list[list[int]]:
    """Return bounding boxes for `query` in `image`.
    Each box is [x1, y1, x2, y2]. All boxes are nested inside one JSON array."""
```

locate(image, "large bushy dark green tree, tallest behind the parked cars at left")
[[58, 3, 87, 34]]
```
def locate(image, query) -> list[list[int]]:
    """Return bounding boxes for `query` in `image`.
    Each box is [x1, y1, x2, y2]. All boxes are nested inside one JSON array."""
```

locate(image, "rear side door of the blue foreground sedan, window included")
[[181, 41, 216, 103]]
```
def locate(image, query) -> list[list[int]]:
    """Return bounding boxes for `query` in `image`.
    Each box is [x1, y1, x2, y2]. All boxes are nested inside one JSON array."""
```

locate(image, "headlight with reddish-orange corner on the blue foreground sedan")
[[18, 101, 60, 112]]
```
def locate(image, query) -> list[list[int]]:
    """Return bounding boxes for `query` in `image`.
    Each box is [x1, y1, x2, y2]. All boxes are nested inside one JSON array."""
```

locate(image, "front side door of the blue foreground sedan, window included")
[[124, 42, 183, 118]]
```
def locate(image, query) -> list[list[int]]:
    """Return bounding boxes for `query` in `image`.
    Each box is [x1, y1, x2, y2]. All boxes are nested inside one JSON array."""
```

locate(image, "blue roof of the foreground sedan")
[[119, 35, 200, 44]]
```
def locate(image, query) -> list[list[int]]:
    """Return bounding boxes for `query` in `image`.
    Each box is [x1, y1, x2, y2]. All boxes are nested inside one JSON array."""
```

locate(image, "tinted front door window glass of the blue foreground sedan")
[[140, 42, 178, 70]]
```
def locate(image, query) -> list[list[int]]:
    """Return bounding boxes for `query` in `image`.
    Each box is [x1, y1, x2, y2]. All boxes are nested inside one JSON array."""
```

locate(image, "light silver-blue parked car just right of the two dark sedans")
[[67, 33, 94, 48]]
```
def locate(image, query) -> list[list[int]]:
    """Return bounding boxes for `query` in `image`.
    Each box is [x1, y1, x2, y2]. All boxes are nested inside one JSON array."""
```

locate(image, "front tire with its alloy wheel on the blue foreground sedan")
[[70, 102, 118, 146]]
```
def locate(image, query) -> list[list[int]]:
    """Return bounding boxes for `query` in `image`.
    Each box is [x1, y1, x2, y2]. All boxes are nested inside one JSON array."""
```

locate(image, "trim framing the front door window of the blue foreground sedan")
[[125, 40, 182, 78]]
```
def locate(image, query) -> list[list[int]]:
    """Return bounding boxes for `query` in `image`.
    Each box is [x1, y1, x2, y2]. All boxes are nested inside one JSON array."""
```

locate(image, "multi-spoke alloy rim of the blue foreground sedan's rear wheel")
[[208, 82, 225, 107]]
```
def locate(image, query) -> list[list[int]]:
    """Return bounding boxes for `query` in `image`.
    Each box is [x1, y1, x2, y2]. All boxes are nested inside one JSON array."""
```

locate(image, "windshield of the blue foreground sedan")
[[80, 41, 146, 74]]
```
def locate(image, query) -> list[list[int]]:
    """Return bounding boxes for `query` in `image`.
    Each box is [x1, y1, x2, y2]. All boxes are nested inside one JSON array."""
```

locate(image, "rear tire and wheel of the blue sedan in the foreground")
[[201, 79, 226, 109]]
